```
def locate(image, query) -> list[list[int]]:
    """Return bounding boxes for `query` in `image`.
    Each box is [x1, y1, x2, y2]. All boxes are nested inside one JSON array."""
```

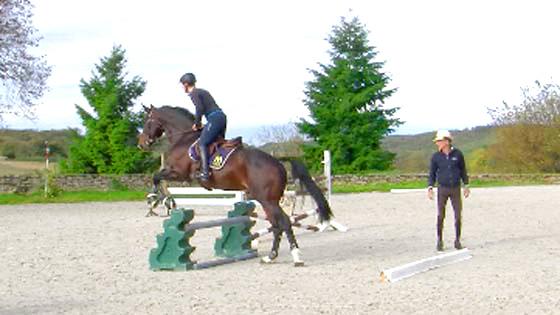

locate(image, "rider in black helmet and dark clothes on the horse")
[[179, 73, 227, 181]]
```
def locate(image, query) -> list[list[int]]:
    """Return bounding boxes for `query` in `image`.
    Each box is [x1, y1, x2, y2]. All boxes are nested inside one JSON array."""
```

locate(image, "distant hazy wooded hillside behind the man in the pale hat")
[[382, 126, 496, 172]]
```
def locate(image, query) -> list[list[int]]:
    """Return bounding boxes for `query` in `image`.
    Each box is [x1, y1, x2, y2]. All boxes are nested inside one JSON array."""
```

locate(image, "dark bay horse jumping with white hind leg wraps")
[[138, 105, 332, 266]]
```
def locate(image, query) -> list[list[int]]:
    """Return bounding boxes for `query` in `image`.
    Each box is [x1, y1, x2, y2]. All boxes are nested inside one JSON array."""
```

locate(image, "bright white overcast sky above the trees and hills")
[[7, 0, 560, 143]]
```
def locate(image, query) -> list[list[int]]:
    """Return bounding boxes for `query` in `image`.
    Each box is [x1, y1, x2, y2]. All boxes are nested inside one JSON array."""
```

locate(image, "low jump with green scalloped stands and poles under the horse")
[[149, 202, 258, 271]]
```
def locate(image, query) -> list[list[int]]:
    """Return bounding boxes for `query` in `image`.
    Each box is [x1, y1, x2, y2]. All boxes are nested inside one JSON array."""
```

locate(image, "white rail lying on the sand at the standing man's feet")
[[380, 248, 472, 282]]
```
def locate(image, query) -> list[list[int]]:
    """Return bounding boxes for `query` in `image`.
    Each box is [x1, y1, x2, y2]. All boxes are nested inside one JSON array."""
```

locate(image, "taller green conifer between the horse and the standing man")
[[298, 18, 402, 173]]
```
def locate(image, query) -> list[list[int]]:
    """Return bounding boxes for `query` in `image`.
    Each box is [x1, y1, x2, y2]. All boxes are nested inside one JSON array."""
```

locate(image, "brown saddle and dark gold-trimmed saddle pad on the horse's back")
[[189, 137, 243, 170]]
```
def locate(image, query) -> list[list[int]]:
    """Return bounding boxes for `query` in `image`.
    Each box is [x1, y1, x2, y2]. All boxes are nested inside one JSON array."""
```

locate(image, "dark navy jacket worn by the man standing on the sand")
[[428, 147, 469, 187]]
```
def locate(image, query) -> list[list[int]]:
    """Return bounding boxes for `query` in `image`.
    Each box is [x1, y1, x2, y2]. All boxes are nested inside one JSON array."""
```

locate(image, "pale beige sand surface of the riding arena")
[[0, 186, 560, 314]]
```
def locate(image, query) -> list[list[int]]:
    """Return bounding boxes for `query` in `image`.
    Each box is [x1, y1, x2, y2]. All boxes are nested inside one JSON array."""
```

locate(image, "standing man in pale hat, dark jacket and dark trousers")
[[428, 130, 470, 251]]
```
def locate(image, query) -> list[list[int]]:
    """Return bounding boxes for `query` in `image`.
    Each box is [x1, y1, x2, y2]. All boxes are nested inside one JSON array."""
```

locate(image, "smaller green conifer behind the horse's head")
[[61, 46, 155, 174]]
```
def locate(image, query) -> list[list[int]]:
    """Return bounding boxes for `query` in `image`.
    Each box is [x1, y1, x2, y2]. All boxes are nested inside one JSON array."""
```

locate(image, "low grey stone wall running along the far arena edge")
[[0, 174, 560, 192]]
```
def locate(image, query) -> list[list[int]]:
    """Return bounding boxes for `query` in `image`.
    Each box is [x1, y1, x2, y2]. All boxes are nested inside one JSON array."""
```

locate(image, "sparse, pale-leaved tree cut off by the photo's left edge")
[[0, 0, 51, 122]]
